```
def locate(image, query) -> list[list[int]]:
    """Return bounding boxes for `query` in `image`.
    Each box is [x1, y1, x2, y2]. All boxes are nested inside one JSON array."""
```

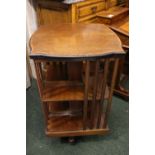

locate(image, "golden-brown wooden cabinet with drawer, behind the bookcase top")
[[37, 0, 106, 25]]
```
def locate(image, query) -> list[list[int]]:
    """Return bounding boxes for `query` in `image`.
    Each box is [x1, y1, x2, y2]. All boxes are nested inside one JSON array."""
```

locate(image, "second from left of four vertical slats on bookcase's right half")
[[90, 60, 99, 128]]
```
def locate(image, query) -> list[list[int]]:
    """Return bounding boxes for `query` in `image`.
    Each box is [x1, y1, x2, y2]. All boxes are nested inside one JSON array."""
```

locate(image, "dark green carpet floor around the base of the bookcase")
[[26, 80, 129, 155]]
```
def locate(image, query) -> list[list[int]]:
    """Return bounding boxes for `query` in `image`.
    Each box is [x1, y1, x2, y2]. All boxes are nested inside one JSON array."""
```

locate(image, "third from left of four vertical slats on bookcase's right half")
[[97, 59, 109, 128]]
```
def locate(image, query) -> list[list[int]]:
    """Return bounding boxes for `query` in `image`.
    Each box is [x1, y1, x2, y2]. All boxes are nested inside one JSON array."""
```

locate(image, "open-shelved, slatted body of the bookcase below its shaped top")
[[35, 59, 118, 137]]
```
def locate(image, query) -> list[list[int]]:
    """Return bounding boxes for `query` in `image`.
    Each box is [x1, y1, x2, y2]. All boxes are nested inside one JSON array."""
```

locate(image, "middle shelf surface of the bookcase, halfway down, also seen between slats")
[[42, 81, 109, 102]]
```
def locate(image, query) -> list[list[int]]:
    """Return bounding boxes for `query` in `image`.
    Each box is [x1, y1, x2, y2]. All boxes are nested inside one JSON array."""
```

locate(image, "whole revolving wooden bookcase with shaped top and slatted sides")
[[30, 24, 124, 137]]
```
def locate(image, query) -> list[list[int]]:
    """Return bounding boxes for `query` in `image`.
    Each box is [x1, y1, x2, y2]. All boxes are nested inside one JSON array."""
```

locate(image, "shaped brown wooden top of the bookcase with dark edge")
[[30, 24, 124, 59]]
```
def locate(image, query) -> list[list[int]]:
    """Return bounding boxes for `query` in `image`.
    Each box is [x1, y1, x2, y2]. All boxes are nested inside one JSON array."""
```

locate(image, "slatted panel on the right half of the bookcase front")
[[87, 58, 119, 129]]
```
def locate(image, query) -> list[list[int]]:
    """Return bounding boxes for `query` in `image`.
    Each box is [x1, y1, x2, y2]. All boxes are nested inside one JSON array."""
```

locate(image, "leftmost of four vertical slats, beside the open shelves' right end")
[[83, 61, 90, 130]]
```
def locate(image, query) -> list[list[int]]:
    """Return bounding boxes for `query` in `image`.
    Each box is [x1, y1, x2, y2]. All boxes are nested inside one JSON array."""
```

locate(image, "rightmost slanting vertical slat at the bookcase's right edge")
[[103, 58, 119, 128]]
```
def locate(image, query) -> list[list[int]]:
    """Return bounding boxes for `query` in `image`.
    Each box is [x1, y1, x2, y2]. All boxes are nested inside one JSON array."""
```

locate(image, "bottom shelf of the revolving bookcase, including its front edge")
[[46, 116, 109, 137]]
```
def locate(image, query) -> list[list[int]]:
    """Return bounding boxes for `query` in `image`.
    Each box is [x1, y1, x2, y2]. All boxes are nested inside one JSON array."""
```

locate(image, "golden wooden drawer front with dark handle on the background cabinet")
[[77, 1, 105, 19]]
